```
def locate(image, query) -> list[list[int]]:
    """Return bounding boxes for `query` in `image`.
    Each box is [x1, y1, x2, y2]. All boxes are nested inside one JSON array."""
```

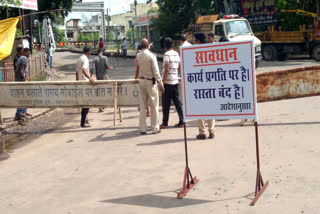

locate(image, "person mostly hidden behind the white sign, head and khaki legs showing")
[[194, 32, 215, 140]]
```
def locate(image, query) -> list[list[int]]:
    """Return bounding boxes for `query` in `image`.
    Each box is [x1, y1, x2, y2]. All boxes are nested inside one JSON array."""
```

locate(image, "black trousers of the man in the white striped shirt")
[[162, 84, 184, 126]]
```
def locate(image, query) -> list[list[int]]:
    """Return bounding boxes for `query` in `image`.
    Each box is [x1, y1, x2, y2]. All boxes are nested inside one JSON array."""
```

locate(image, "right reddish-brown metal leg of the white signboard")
[[250, 122, 269, 206]]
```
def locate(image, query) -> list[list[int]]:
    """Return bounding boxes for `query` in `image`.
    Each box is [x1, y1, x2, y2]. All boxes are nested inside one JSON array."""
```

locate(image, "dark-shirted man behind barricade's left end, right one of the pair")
[[14, 48, 31, 120]]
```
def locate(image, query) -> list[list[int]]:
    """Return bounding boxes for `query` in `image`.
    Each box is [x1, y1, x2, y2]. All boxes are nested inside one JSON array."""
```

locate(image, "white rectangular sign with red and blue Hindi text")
[[180, 41, 257, 120]]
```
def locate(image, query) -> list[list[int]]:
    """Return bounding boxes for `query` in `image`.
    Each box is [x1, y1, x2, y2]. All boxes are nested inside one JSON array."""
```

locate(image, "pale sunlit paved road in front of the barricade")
[[0, 51, 320, 214]]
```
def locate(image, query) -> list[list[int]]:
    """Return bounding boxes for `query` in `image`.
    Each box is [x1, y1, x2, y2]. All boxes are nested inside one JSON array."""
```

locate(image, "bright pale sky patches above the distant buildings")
[[66, 0, 147, 20]]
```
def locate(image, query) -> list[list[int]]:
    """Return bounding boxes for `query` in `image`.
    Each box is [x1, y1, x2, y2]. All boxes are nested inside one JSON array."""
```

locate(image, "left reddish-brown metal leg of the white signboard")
[[177, 123, 199, 199]]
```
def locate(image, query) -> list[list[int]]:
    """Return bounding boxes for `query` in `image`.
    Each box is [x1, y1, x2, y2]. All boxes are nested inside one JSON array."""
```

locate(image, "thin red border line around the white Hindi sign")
[[182, 42, 256, 118]]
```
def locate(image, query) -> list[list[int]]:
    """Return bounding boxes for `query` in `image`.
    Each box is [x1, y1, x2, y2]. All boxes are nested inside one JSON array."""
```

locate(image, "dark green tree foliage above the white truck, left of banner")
[[152, 0, 216, 37]]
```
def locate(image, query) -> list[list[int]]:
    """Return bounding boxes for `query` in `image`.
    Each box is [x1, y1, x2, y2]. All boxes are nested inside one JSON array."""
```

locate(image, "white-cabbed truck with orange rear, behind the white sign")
[[196, 15, 262, 67]]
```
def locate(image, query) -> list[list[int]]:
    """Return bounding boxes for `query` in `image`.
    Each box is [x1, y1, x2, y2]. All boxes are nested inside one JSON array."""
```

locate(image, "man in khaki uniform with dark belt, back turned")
[[137, 38, 164, 135]]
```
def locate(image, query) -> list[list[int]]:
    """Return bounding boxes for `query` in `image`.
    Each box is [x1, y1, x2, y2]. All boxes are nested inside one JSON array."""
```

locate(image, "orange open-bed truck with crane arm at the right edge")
[[255, 9, 320, 61]]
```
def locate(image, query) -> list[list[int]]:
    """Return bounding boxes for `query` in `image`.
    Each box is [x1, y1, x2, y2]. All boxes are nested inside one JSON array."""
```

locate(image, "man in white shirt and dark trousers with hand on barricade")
[[76, 46, 94, 128]]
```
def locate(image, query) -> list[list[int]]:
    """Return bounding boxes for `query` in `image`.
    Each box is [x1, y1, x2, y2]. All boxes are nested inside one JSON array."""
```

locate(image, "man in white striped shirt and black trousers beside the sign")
[[160, 38, 184, 129]]
